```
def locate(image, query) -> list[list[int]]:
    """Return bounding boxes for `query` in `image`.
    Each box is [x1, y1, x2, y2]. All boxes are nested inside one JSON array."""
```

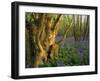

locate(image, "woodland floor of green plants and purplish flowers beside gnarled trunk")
[[27, 36, 89, 68]]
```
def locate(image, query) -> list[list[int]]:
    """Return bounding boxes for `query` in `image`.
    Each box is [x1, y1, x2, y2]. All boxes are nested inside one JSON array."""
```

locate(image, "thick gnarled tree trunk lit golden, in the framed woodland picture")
[[33, 14, 61, 67]]
